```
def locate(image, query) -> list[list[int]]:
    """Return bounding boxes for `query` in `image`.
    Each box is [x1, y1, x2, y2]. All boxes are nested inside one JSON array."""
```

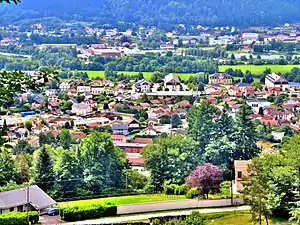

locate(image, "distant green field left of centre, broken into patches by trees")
[[81, 71, 195, 80]]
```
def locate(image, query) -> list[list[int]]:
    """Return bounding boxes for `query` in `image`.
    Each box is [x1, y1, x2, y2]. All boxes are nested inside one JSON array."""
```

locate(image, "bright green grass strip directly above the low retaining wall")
[[58, 195, 185, 207]]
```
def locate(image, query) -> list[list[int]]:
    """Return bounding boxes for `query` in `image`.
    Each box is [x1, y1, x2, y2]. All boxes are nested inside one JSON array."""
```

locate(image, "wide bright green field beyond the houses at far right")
[[219, 65, 300, 75]]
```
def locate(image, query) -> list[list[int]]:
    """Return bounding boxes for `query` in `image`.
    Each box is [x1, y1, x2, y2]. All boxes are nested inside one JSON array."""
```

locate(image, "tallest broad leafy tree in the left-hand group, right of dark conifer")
[[78, 131, 125, 193]]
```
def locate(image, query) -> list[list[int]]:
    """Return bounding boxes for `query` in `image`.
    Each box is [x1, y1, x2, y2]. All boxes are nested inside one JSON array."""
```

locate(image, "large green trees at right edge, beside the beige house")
[[245, 135, 300, 221]]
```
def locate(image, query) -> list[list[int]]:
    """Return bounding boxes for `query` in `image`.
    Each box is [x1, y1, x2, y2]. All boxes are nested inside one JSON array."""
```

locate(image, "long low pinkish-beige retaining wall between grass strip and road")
[[117, 199, 243, 215]]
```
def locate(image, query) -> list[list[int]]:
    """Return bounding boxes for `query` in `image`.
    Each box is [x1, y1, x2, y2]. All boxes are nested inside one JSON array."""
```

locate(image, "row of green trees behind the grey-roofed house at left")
[[0, 132, 147, 198]]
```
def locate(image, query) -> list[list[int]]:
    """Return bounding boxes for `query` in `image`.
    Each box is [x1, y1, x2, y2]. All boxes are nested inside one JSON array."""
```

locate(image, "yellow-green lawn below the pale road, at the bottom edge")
[[204, 211, 290, 225]]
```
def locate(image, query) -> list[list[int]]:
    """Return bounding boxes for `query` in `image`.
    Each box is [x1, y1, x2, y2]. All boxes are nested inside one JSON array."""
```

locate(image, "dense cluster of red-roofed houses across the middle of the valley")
[[0, 73, 300, 178]]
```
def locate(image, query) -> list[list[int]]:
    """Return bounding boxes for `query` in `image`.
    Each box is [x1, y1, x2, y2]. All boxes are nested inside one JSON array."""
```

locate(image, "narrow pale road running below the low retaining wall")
[[64, 206, 250, 225]]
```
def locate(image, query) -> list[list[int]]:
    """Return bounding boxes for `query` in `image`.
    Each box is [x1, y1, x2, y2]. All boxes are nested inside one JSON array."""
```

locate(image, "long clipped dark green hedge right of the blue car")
[[61, 204, 117, 222]]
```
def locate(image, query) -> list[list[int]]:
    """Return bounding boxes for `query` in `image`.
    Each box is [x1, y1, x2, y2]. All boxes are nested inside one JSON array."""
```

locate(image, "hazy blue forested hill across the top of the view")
[[0, 0, 300, 26]]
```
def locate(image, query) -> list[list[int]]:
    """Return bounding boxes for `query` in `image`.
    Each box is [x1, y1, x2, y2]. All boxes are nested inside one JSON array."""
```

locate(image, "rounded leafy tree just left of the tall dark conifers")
[[142, 135, 198, 191]]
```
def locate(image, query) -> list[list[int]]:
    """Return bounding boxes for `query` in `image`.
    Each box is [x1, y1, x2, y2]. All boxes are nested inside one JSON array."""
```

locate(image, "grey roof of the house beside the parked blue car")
[[0, 185, 56, 210]]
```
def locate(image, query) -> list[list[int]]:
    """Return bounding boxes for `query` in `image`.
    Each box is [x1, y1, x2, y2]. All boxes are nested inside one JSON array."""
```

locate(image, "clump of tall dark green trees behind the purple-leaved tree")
[[142, 102, 260, 191]]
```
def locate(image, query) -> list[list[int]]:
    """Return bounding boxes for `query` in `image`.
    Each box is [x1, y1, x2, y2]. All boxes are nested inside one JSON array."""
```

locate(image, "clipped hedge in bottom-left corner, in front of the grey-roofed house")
[[0, 212, 39, 225]]
